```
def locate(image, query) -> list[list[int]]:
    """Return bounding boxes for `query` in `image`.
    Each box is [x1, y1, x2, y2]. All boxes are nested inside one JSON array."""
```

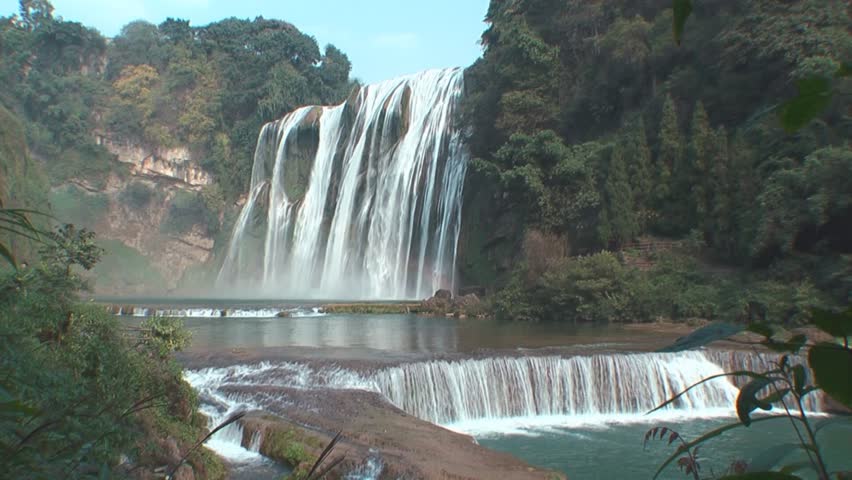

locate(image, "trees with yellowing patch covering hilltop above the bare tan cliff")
[[0, 1, 352, 199]]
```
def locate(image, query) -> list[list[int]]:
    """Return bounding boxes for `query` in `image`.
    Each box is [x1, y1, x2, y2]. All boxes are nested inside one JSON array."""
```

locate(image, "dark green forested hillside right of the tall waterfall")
[[460, 0, 852, 320]]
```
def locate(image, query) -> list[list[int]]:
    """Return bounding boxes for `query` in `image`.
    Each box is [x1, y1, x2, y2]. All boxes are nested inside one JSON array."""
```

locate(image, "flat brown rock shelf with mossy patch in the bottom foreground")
[[236, 387, 565, 480]]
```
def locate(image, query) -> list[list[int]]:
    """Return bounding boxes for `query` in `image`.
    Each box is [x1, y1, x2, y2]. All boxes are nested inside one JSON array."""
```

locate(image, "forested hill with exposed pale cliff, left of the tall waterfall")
[[0, 0, 354, 294]]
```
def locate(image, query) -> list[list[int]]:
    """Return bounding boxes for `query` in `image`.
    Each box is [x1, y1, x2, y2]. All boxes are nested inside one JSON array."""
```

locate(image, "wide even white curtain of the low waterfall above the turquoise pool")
[[374, 352, 738, 424]]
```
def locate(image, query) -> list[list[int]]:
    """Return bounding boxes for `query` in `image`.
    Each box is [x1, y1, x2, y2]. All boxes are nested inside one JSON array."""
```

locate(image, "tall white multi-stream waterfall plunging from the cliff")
[[217, 69, 467, 299]]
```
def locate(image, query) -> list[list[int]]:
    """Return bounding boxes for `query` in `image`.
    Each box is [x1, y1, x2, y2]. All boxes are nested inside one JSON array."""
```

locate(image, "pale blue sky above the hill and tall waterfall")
[[0, 0, 488, 83]]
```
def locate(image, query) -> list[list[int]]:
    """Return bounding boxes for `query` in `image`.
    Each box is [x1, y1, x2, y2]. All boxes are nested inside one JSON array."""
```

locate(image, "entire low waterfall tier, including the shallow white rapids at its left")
[[183, 351, 821, 432]]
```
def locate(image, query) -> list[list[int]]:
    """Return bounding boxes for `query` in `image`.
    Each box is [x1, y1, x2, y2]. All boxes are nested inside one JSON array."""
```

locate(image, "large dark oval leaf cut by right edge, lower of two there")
[[808, 342, 852, 408]]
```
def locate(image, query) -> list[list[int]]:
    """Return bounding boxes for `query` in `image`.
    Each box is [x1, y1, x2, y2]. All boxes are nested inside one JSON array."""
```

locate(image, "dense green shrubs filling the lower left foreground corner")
[[0, 225, 224, 478]]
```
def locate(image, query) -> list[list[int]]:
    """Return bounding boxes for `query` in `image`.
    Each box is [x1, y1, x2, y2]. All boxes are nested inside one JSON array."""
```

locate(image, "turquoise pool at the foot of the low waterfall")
[[477, 419, 852, 480]]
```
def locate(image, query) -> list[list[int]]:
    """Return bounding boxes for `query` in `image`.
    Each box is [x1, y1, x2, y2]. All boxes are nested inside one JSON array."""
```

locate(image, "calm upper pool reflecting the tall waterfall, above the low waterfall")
[[163, 315, 648, 353]]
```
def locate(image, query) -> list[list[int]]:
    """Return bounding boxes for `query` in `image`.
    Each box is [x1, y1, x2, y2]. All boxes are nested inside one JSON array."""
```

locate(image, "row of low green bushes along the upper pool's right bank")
[[494, 248, 831, 325]]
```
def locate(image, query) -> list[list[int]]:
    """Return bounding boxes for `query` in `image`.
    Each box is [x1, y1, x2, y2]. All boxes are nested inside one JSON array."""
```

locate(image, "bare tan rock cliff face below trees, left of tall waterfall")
[[50, 136, 224, 295]]
